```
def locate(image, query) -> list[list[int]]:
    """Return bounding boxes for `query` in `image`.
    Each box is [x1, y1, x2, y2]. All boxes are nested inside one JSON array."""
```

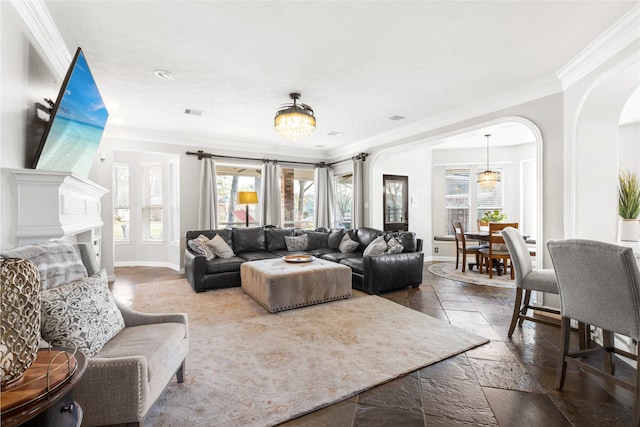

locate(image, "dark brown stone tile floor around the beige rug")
[[112, 267, 634, 427]]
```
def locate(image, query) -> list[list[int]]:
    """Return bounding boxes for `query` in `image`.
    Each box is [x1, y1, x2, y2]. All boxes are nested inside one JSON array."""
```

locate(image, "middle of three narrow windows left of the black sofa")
[[142, 163, 164, 241]]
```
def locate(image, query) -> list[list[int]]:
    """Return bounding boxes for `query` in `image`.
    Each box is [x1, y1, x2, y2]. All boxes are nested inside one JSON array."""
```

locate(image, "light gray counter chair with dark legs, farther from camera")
[[502, 227, 560, 338]]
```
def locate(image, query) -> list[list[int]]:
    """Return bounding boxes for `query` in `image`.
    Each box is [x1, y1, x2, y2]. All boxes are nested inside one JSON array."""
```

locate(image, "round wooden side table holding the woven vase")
[[0, 349, 87, 427]]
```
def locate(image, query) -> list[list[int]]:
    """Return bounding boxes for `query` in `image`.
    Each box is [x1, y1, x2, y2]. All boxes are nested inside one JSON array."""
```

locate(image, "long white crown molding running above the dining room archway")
[[330, 76, 562, 158]]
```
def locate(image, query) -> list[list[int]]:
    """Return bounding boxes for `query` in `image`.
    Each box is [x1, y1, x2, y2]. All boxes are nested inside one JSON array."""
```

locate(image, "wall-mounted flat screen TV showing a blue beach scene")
[[33, 48, 109, 178]]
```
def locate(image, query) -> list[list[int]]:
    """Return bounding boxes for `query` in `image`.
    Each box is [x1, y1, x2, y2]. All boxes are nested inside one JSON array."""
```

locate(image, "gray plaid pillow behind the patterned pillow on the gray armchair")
[[2, 242, 88, 289]]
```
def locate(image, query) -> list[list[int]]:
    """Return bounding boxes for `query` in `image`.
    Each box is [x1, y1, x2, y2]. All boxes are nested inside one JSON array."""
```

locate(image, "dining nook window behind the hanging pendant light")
[[444, 166, 504, 236]]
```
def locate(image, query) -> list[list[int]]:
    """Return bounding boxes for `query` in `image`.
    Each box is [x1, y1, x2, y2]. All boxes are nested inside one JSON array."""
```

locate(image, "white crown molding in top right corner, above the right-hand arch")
[[556, 4, 640, 90]]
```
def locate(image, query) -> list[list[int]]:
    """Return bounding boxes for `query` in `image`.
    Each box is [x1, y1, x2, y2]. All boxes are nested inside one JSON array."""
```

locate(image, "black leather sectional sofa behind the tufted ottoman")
[[184, 226, 424, 294]]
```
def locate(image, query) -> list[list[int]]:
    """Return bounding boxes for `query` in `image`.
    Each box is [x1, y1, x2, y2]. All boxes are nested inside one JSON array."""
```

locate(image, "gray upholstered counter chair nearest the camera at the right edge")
[[547, 239, 640, 426]]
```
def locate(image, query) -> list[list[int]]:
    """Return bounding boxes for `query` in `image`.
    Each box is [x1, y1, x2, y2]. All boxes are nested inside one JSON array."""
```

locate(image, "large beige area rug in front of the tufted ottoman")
[[133, 280, 488, 426]]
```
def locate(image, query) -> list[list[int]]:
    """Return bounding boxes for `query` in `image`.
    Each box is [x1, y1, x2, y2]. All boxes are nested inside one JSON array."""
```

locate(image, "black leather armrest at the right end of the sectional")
[[363, 252, 424, 295]]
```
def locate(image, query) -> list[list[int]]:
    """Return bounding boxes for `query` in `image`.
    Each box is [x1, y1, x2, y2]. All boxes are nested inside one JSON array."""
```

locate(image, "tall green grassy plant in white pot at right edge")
[[618, 169, 640, 242]]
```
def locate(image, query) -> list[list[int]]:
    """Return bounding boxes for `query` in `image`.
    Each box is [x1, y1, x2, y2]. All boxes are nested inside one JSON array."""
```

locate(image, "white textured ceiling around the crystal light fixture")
[[45, 0, 637, 158]]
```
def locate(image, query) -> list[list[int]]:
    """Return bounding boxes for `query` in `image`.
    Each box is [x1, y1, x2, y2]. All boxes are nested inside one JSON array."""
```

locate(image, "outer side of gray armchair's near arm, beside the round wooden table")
[[73, 356, 151, 425]]
